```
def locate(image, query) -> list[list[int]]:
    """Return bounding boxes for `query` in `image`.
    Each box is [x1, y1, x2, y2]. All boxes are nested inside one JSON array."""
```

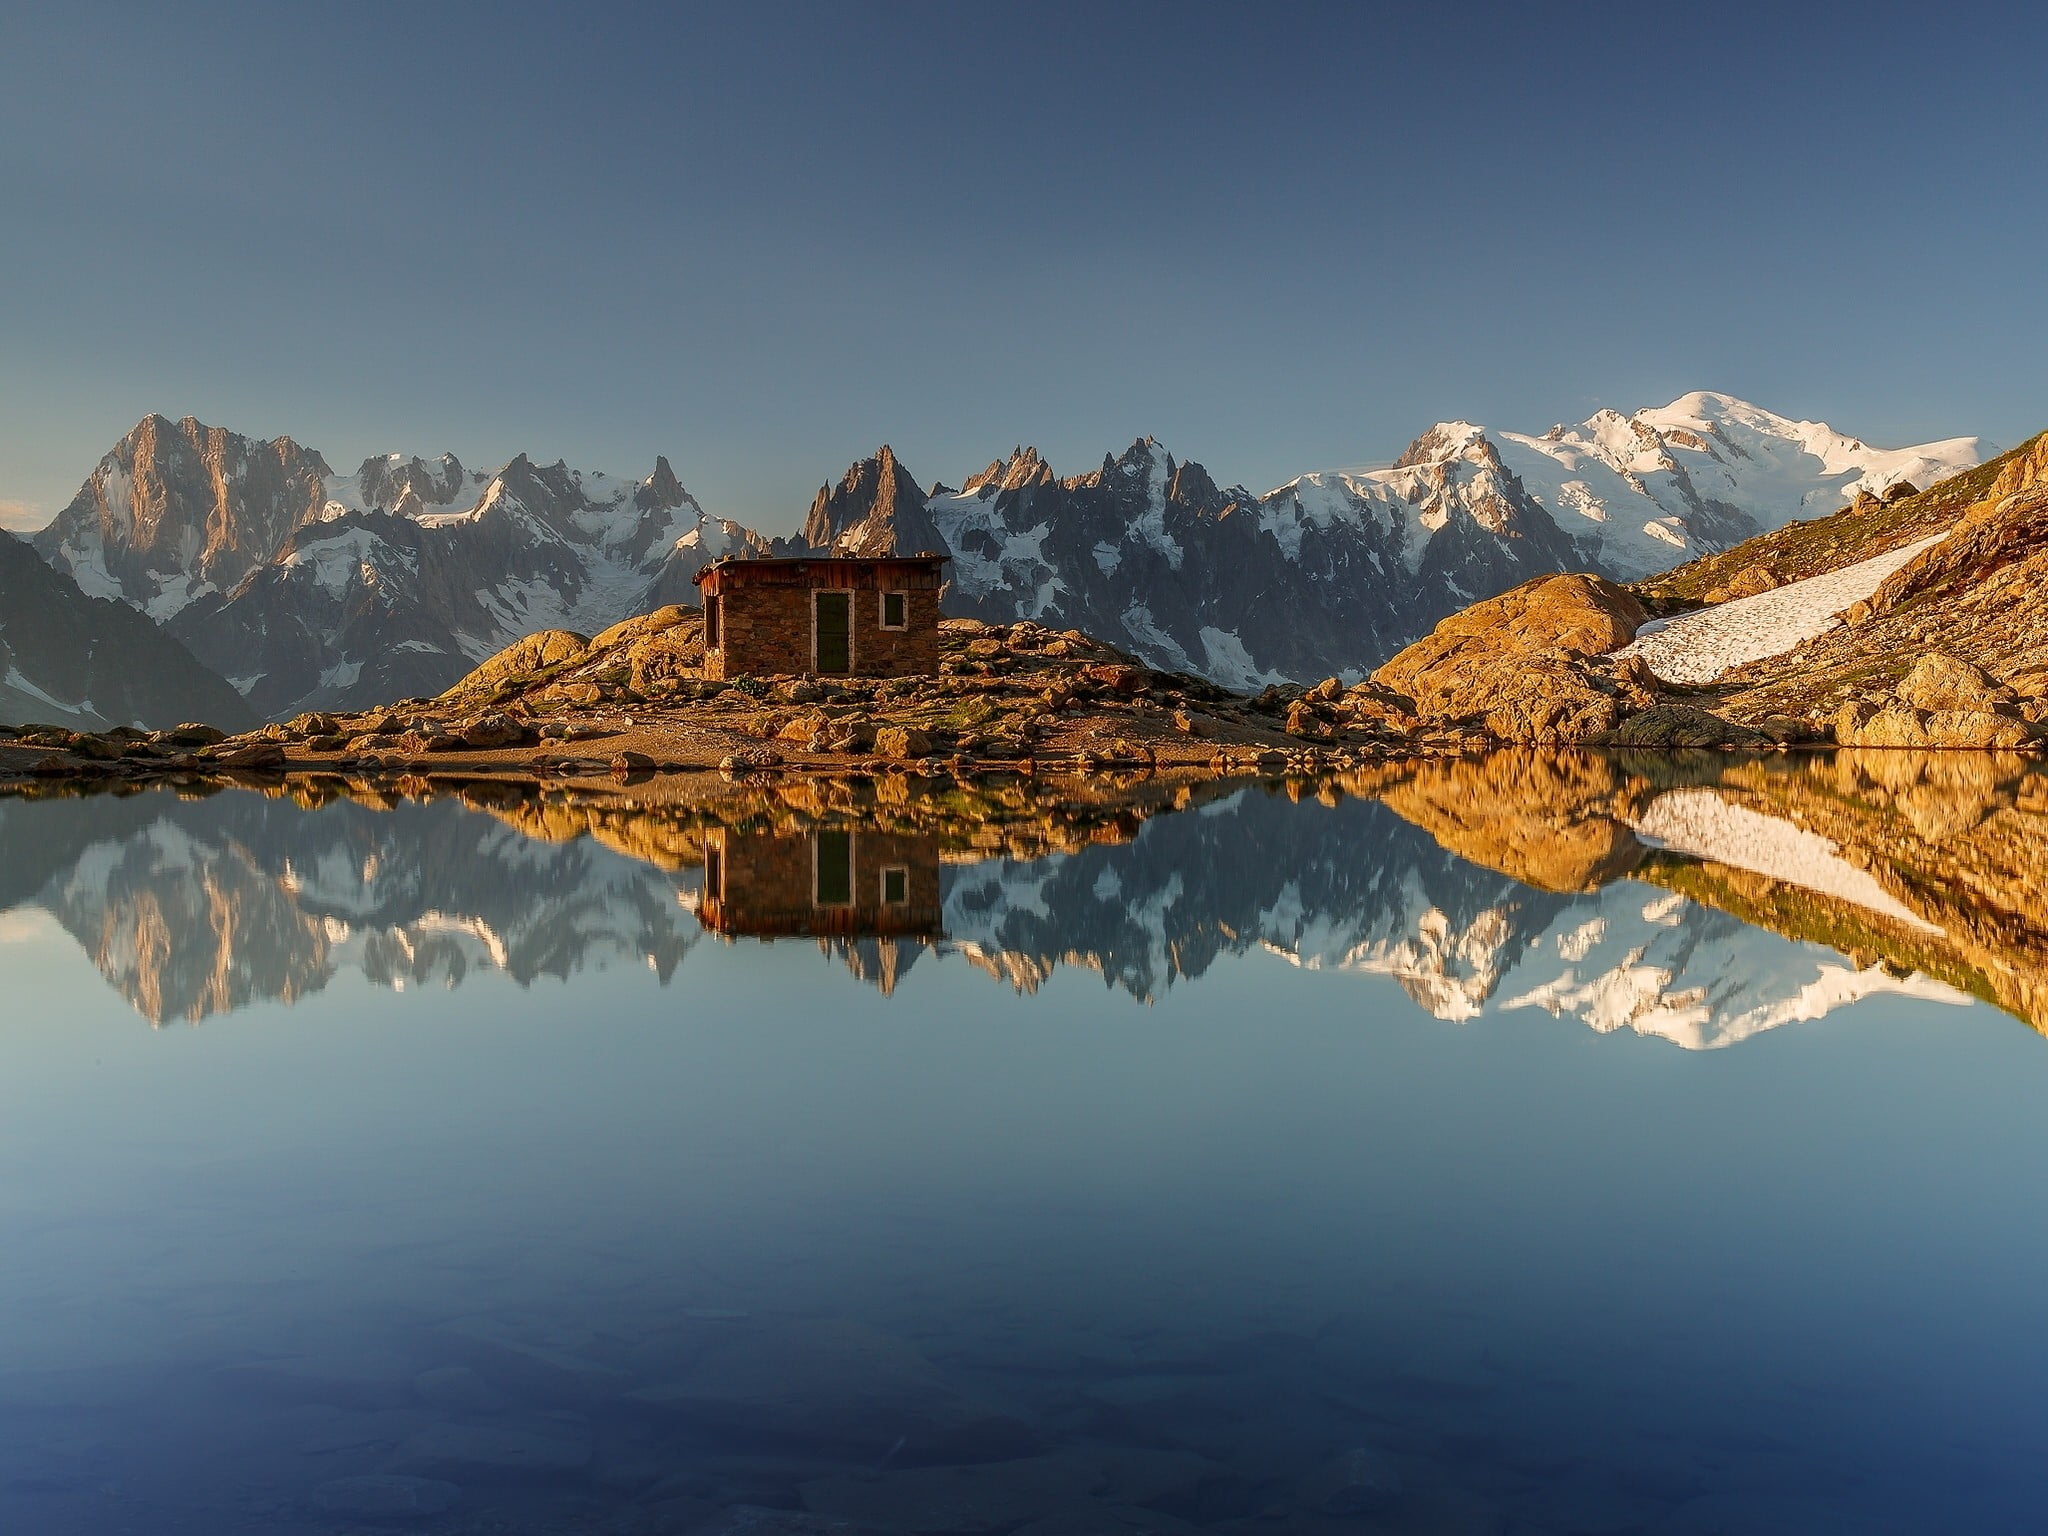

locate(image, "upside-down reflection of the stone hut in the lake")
[[696, 827, 944, 938]]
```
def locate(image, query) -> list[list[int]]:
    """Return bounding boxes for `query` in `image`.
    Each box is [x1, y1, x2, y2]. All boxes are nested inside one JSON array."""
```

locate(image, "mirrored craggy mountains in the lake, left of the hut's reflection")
[[0, 795, 700, 1022]]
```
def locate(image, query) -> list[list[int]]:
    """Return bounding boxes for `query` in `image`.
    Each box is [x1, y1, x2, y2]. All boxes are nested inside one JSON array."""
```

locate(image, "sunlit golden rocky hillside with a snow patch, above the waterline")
[[1343, 434, 2048, 748]]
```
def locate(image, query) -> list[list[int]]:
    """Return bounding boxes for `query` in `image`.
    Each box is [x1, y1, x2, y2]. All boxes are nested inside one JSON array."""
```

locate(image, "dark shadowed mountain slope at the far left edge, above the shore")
[[0, 532, 256, 729]]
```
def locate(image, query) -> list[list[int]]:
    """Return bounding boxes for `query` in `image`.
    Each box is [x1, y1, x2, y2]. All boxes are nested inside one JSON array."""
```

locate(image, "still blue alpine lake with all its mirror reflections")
[[0, 750, 2048, 1536]]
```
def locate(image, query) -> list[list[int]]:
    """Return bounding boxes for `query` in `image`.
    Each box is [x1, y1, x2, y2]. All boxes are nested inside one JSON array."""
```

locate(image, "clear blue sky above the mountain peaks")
[[0, 0, 2048, 530]]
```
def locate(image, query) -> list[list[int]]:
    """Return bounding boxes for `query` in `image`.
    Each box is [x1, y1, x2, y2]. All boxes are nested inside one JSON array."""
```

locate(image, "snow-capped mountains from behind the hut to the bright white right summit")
[[805, 393, 1993, 688]]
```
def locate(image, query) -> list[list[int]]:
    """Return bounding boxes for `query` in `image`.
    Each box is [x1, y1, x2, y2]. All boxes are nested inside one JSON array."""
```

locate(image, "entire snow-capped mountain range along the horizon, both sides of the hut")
[[19, 393, 1991, 717]]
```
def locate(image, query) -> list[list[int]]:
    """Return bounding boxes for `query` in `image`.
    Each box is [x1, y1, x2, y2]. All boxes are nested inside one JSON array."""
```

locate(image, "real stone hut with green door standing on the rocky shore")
[[696, 555, 948, 678]]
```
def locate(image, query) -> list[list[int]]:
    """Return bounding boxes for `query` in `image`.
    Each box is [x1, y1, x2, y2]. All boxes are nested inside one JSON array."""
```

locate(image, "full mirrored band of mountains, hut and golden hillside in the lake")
[[0, 754, 2048, 1049]]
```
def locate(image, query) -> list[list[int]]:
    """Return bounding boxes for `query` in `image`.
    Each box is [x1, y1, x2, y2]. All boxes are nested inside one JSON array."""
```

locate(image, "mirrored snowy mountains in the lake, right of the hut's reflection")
[[944, 791, 1966, 1051]]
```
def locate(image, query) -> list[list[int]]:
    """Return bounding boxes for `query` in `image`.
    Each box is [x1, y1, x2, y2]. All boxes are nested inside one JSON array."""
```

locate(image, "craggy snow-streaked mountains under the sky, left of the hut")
[[35, 416, 770, 717]]
